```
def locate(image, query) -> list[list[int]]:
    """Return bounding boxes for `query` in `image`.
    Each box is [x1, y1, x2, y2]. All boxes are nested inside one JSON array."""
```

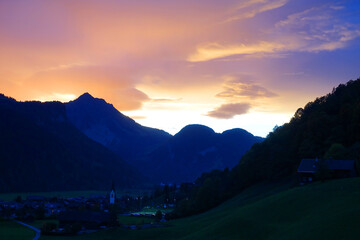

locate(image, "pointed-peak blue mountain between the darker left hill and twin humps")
[[65, 93, 171, 166]]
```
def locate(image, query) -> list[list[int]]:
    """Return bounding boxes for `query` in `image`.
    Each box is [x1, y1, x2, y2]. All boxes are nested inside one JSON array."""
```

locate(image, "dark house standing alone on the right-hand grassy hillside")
[[297, 158, 356, 183]]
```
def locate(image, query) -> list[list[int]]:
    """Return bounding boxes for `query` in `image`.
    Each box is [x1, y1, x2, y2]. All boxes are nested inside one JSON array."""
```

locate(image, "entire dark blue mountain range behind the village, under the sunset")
[[0, 93, 262, 191]]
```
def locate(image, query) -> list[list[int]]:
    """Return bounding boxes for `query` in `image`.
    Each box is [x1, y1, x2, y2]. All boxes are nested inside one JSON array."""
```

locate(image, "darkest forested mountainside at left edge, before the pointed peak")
[[0, 95, 141, 192]]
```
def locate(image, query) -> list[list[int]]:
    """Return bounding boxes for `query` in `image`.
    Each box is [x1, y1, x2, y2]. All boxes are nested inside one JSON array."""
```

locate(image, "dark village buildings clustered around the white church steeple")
[[0, 185, 146, 229]]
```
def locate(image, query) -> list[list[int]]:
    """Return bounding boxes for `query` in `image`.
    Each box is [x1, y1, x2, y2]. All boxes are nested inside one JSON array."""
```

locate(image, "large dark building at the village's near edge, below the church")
[[58, 211, 111, 229]]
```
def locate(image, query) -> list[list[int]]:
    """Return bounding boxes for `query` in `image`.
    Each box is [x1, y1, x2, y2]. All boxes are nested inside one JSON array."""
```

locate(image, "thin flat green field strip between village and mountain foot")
[[0, 189, 151, 201]]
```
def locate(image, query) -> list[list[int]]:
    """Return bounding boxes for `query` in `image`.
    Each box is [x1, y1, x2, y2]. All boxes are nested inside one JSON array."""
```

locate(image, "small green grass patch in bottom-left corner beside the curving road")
[[0, 221, 35, 240]]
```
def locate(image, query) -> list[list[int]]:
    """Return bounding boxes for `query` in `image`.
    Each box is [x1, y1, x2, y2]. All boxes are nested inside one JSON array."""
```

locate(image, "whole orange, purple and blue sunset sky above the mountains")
[[0, 0, 360, 137]]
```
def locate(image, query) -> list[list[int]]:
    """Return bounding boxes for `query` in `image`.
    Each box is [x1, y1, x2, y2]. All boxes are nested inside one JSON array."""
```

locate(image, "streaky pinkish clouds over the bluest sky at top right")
[[274, 4, 360, 52]]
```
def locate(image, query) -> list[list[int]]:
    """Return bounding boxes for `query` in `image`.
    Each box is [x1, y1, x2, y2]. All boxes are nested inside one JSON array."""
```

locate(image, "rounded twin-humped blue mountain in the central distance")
[[144, 125, 263, 183]]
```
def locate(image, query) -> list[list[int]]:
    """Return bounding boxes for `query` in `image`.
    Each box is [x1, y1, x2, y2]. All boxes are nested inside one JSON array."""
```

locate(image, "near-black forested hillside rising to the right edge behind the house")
[[234, 79, 360, 186]]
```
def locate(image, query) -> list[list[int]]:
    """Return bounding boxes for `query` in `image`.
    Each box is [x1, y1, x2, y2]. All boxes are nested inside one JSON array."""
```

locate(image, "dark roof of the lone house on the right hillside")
[[297, 158, 355, 173]]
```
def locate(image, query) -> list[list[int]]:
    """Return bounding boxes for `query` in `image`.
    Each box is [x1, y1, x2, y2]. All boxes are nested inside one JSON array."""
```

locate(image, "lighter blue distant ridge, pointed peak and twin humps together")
[[65, 93, 262, 182]]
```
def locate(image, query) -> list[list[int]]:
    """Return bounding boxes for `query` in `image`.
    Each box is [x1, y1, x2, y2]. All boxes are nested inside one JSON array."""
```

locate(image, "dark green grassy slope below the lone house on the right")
[[41, 178, 360, 240]]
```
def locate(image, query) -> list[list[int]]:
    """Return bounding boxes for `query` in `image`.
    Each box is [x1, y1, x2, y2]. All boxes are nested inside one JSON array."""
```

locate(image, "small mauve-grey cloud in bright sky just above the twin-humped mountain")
[[207, 103, 250, 119]]
